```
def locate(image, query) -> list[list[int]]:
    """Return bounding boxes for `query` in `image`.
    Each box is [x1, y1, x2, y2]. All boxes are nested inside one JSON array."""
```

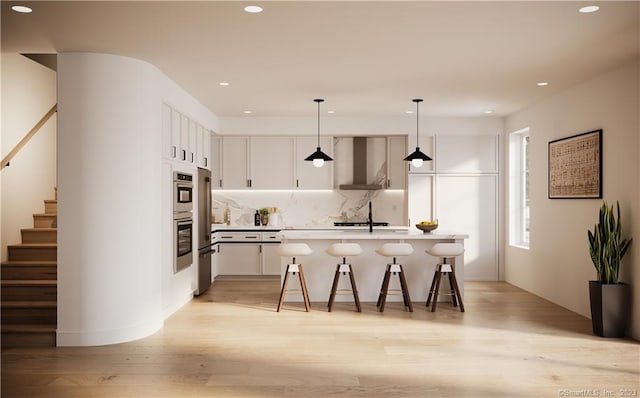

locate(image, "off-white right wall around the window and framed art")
[[504, 60, 640, 339]]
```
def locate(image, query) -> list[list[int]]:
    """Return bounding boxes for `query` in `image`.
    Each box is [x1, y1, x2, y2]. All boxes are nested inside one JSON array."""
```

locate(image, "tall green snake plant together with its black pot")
[[588, 201, 632, 337]]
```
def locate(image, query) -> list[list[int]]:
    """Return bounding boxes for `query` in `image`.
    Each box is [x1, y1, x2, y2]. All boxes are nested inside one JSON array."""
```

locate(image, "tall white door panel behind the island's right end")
[[435, 175, 499, 281]]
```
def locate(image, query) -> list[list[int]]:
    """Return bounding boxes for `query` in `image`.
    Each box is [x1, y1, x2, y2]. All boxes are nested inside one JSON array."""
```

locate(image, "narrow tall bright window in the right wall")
[[509, 128, 530, 248]]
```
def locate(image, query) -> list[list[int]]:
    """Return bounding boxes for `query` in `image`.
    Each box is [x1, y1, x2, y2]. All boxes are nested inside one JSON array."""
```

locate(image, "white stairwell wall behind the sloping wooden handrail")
[[0, 53, 56, 261]]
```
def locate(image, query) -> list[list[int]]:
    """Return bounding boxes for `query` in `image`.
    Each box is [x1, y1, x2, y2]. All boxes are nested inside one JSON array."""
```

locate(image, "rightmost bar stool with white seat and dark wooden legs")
[[425, 243, 464, 312]]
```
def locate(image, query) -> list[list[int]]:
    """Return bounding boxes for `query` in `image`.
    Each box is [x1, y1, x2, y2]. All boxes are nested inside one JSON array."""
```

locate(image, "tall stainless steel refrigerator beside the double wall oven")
[[196, 168, 213, 295]]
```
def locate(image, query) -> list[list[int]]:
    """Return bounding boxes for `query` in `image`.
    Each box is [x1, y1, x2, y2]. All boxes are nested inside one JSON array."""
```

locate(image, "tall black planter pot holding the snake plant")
[[589, 281, 631, 337]]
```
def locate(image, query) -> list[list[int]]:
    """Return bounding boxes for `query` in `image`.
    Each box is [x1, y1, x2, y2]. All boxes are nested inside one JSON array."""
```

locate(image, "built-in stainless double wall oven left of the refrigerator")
[[172, 171, 193, 273]]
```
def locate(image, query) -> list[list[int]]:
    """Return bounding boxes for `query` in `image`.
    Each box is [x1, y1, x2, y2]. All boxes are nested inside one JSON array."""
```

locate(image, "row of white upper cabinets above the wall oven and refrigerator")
[[162, 104, 211, 169]]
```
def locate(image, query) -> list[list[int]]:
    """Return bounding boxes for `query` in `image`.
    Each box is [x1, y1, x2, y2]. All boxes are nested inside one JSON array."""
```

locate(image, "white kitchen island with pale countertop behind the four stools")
[[277, 227, 468, 304]]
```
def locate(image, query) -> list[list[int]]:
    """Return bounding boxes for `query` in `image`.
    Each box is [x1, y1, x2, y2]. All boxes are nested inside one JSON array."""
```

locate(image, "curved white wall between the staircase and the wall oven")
[[58, 53, 216, 346]]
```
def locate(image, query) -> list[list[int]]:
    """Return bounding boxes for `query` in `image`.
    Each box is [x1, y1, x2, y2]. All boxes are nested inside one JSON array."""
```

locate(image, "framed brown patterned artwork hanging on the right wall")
[[549, 129, 602, 199]]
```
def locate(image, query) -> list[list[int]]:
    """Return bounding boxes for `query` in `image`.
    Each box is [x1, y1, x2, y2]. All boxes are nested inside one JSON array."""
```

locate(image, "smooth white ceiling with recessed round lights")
[[1, 0, 640, 117]]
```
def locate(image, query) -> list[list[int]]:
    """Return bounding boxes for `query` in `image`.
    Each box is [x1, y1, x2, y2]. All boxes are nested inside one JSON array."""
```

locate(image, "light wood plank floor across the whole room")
[[1, 280, 640, 398]]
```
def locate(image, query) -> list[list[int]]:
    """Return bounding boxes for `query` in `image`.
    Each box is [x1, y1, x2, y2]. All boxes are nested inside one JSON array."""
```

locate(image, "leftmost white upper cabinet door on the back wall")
[[220, 136, 250, 189]]
